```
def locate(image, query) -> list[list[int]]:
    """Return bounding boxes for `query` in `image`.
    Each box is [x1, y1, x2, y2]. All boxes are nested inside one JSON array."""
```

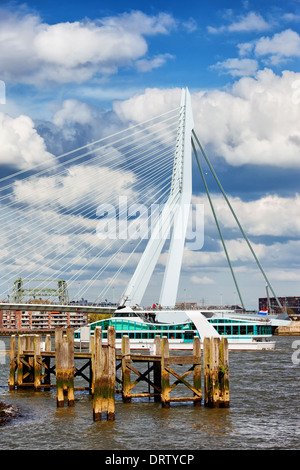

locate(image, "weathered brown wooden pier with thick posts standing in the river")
[[8, 327, 229, 421]]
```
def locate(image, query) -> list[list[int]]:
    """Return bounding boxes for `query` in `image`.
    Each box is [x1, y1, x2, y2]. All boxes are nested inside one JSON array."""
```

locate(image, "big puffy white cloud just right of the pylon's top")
[[192, 69, 300, 168]]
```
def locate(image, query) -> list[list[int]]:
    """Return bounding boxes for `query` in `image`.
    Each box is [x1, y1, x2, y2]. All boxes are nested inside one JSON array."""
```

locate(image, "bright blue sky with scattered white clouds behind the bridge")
[[0, 0, 300, 309]]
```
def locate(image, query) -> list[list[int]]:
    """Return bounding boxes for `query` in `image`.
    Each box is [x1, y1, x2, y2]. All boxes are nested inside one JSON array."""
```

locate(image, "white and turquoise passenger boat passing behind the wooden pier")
[[75, 306, 288, 351]]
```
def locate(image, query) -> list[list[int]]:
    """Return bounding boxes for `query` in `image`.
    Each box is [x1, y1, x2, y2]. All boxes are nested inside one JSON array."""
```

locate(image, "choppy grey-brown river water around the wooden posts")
[[0, 336, 300, 452]]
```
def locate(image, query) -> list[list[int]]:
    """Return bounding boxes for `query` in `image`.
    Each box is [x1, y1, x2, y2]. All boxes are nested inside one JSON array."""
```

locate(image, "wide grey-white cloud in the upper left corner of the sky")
[[0, 10, 176, 84]]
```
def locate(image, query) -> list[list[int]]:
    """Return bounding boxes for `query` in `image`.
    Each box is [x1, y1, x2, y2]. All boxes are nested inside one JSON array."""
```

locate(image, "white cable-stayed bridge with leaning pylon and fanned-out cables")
[[0, 90, 282, 311]]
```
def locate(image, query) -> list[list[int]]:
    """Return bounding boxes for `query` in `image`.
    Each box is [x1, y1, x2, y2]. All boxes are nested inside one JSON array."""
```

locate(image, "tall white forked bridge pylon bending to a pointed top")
[[120, 89, 194, 307]]
